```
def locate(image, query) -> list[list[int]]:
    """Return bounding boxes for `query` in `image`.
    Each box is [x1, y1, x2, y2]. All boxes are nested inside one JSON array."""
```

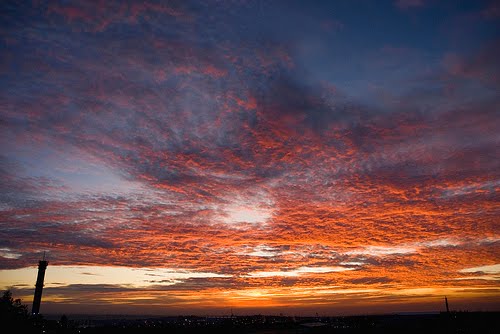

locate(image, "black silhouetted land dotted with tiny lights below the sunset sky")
[[6, 312, 500, 334]]
